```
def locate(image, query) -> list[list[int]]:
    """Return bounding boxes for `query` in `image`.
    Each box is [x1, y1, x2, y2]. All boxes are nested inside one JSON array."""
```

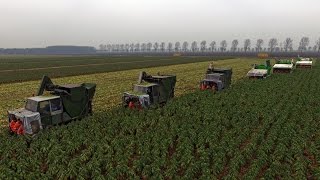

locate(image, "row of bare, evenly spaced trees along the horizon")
[[99, 37, 320, 52]]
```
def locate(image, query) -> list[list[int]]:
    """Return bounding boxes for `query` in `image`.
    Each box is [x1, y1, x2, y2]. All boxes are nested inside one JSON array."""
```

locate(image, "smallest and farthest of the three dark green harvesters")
[[200, 67, 232, 92]]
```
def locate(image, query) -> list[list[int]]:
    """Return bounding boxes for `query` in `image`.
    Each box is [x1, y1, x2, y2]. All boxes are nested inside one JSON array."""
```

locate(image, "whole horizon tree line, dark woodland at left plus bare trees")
[[0, 37, 320, 56]]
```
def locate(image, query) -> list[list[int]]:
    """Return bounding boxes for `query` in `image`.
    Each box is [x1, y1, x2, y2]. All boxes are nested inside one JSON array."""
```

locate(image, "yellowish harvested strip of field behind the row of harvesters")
[[0, 59, 263, 124]]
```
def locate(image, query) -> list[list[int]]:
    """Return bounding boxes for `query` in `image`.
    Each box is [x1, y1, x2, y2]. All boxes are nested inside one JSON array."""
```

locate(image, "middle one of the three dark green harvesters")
[[122, 72, 176, 109]]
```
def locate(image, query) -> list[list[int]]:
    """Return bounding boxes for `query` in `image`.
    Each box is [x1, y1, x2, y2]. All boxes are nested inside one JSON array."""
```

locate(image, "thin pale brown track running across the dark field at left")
[[0, 59, 172, 73]]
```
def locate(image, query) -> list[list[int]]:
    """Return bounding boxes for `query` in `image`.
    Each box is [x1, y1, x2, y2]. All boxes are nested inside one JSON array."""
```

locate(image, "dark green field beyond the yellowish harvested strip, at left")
[[0, 56, 229, 83]]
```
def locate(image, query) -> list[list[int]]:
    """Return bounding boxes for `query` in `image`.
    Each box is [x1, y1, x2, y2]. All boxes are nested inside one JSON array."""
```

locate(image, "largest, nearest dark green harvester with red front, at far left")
[[8, 76, 96, 135]]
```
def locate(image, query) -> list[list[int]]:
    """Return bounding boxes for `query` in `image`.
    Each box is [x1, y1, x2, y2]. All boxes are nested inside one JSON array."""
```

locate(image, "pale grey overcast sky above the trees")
[[0, 0, 320, 48]]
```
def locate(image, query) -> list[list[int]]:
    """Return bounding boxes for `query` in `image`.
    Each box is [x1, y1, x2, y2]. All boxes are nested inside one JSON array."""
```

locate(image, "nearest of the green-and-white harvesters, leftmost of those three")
[[247, 60, 271, 79]]
